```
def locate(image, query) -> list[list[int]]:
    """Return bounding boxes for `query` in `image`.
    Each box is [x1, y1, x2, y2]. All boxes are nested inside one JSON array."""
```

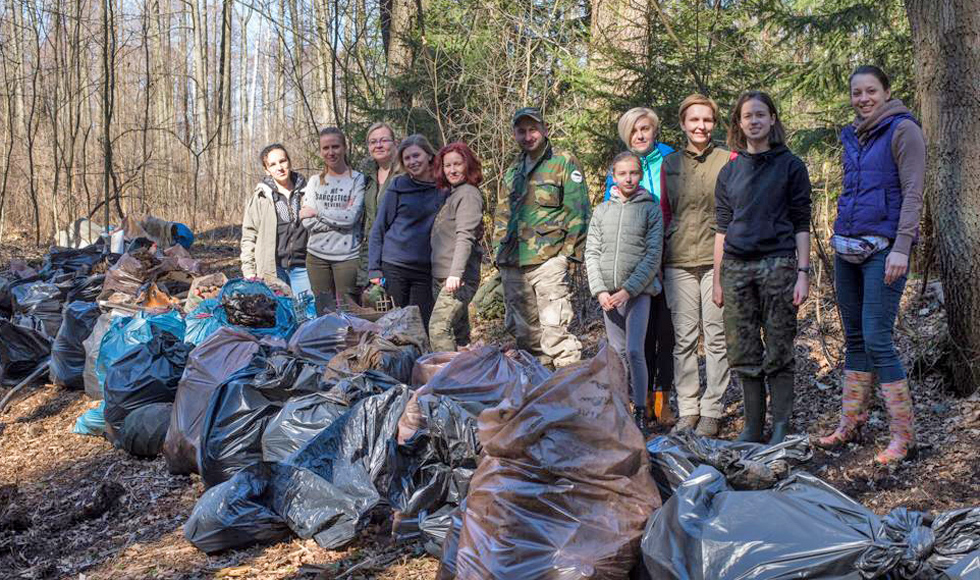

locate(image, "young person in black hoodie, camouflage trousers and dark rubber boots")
[[713, 91, 810, 445]]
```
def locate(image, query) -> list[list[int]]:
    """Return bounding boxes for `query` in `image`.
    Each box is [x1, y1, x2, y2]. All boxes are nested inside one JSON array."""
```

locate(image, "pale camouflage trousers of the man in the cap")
[[500, 256, 582, 367]]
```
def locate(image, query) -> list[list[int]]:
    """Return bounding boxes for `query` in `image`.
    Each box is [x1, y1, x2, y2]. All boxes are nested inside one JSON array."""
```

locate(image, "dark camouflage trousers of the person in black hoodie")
[[721, 256, 797, 378]]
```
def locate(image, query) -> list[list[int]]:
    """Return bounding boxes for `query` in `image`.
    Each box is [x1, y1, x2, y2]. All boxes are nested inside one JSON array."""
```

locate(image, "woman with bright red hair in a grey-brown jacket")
[[429, 141, 483, 351]]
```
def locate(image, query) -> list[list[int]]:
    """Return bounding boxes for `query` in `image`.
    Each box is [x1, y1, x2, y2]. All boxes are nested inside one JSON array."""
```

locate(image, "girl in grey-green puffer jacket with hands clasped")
[[585, 152, 664, 435]]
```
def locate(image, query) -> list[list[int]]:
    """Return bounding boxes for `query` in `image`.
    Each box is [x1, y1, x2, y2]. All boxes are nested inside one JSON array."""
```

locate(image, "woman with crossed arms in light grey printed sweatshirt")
[[299, 127, 364, 314]]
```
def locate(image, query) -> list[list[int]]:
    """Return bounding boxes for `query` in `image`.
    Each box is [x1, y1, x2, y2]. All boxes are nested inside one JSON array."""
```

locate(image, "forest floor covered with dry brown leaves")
[[0, 229, 980, 579]]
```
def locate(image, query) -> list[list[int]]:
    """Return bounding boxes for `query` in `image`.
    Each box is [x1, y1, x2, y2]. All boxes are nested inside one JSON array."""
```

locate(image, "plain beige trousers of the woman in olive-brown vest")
[[664, 267, 730, 419]]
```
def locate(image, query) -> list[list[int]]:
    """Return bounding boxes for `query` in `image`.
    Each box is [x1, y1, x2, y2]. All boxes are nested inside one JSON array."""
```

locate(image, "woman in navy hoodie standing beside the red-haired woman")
[[368, 135, 446, 328]]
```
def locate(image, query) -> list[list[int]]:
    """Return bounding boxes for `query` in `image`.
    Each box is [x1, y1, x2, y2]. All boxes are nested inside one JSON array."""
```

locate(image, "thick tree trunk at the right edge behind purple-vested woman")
[[905, 0, 980, 394]]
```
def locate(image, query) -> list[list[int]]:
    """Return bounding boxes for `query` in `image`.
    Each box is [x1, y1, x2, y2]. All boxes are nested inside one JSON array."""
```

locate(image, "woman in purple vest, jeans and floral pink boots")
[[817, 66, 926, 464]]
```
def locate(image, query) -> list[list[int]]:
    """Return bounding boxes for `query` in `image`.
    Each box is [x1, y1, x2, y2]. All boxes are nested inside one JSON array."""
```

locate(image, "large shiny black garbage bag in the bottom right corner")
[[642, 465, 980, 580]]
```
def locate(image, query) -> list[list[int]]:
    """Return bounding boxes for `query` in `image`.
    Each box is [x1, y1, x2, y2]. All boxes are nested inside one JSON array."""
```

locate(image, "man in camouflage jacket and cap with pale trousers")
[[493, 107, 591, 367]]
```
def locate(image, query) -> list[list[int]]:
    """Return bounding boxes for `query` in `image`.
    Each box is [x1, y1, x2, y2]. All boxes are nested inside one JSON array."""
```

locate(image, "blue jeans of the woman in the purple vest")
[[834, 247, 906, 383]]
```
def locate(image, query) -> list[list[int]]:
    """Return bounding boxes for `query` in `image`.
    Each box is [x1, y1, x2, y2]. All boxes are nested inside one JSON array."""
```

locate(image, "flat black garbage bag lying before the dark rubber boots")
[[647, 432, 813, 500]]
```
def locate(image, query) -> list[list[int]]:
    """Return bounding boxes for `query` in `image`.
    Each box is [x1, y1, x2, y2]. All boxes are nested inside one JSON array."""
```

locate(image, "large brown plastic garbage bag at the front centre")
[[440, 348, 660, 580]]
